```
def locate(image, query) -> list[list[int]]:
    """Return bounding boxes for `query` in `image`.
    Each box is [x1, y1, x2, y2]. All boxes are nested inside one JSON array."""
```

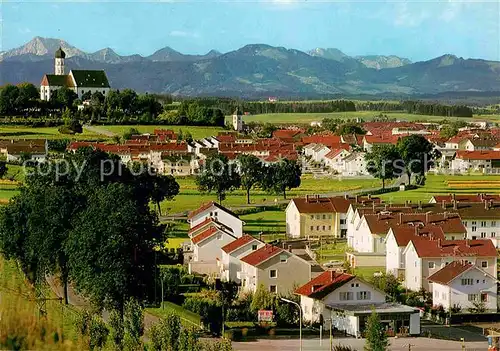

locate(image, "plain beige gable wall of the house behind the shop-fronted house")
[[257, 251, 311, 294]]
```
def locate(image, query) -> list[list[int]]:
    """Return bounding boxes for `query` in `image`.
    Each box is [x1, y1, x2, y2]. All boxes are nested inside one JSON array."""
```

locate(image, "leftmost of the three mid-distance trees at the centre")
[[196, 154, 241, 203]]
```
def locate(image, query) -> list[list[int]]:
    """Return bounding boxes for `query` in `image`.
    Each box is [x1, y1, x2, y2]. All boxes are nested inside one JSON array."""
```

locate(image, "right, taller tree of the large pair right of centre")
[[396, 134, 435, 184]]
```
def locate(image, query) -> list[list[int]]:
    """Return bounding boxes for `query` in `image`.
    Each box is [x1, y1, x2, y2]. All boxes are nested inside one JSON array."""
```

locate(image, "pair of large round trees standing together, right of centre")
[[365, 135, 437, 189]]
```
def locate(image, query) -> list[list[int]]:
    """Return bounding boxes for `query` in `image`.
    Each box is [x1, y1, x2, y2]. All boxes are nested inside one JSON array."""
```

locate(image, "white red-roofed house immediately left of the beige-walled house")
[[219, 234, 265, 283]]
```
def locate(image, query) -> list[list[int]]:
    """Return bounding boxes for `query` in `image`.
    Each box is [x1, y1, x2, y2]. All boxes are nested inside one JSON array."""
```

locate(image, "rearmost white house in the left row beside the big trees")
[[188, 201, 244, 238]]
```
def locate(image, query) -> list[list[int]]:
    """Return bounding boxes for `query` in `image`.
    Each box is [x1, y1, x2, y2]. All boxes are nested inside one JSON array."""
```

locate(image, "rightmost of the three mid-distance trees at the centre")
[[262, 159, 302, 199]]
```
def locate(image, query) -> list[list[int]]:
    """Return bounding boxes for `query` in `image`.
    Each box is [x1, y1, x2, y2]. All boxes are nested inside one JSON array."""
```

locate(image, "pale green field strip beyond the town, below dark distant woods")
[[226, 111, 500, 124]]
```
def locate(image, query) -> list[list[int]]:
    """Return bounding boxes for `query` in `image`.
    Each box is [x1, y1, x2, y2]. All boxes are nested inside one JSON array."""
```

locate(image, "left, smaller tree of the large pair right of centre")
[[365, 144, 401, 189]]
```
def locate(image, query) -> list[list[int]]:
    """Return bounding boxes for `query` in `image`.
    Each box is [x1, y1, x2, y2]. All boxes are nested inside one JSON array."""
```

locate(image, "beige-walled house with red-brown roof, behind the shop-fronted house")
[[238, 244, 311, 294]]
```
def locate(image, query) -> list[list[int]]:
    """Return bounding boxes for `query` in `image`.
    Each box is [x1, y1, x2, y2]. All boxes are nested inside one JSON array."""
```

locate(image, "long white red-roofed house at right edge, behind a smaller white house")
[[403, 239, 497, 291]]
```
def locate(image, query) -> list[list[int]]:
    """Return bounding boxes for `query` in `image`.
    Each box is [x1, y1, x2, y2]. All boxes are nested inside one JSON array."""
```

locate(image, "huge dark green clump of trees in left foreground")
[[0, 148, 178, 328]]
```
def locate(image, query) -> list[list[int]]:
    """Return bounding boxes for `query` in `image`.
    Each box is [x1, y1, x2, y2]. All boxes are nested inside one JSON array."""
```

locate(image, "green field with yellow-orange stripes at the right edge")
[[380, 174, 500, 203]]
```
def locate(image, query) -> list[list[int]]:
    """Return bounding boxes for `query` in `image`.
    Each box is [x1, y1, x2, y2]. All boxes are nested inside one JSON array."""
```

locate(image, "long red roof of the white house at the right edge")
[[411, 239, 497, 257]]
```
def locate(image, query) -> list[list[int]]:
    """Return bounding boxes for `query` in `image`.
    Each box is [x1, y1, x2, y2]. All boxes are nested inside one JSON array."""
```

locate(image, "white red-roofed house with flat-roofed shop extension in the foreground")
[[295, 271, 420, 336]]
